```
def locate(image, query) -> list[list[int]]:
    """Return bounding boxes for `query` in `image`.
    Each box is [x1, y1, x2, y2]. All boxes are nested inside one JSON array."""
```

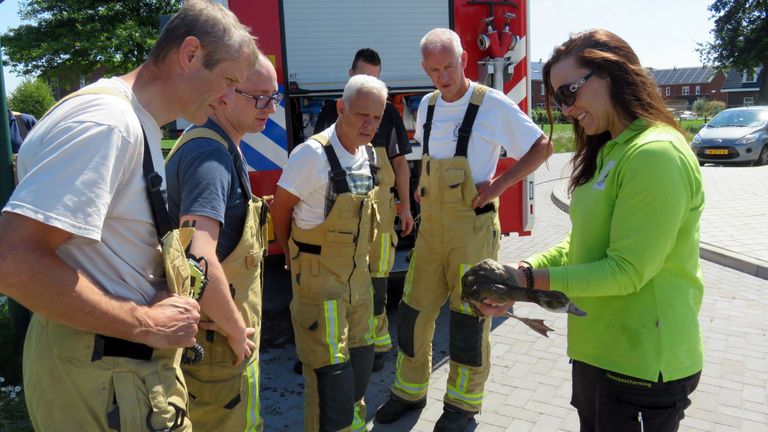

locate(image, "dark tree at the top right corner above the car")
[[698, 0, 768, 104]]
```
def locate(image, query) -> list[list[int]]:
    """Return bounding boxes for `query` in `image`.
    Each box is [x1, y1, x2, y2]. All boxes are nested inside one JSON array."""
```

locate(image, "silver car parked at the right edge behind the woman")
[[691, 106, 768, 165]]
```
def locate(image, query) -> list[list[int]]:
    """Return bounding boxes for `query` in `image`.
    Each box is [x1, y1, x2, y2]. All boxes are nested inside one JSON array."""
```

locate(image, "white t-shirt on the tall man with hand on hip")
[[414, 82, 544, 184]]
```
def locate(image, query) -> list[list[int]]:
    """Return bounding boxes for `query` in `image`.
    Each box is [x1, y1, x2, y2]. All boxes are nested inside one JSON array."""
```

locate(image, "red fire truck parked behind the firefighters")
[[222, 0, 534, 264]]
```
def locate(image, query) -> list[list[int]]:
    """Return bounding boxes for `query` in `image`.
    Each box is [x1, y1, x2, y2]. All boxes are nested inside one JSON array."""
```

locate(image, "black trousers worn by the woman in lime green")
[[571, 360, 701, 432]]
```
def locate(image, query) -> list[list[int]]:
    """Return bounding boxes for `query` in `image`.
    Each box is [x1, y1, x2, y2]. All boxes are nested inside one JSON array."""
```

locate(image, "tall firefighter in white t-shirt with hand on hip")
[[376, 28, 552, 431]]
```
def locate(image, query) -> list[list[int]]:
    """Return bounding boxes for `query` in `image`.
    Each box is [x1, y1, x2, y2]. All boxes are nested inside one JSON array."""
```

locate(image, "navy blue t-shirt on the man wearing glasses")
[[165, 119, 251, 261]]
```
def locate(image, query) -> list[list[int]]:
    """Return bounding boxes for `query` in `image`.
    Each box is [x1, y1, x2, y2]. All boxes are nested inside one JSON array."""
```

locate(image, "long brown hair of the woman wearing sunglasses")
[[542, 29, 680, 192]]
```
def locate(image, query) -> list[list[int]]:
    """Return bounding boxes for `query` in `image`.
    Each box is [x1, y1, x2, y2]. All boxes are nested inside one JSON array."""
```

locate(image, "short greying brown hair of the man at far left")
[[149, 0, 261, 70]]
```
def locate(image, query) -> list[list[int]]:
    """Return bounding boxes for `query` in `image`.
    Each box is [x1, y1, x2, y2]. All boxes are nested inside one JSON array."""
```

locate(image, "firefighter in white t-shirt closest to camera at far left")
[[0, 0, 259, 432]]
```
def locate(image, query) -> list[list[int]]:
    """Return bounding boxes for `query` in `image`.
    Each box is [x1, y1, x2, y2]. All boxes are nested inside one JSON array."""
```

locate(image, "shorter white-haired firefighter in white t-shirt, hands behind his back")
[[271, 75, 387, 432]]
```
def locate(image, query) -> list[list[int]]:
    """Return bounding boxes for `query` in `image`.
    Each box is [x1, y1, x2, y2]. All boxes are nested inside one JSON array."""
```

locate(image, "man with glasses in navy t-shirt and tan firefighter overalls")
[[166, 55, 281, 431]]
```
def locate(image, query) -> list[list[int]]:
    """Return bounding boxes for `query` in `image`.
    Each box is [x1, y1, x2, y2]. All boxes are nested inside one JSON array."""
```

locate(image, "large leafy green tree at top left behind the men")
[[0, 0, 182, 90]]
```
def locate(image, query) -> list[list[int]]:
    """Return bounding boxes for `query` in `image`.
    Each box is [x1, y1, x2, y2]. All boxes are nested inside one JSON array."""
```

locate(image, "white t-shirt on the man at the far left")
[[3, 78, 166, 304]]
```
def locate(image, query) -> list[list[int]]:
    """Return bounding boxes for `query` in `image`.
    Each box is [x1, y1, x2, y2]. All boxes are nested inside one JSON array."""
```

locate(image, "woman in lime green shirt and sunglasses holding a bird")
[[480, 30, 704, 431]]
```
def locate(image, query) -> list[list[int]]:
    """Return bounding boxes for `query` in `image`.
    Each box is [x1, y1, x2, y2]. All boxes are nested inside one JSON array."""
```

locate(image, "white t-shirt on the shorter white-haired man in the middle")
[[277, 123, 375, 229]]
